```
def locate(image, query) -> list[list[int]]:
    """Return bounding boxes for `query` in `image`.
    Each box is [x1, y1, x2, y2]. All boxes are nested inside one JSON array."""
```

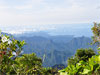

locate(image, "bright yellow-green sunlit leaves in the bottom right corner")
[[60, 55, 100, 75]]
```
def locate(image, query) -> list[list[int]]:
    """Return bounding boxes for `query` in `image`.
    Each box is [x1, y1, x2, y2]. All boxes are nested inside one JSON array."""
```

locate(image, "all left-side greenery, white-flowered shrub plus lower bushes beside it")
[[0, 35, 58, 75]]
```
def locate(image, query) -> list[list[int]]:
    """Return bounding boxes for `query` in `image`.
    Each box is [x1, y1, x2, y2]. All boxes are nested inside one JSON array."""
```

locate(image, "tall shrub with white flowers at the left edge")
[[0, 35, 25, 73]]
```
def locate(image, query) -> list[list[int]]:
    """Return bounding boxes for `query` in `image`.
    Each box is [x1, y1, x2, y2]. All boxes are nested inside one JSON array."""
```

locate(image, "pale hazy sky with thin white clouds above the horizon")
[[0, 0, 100, 26]]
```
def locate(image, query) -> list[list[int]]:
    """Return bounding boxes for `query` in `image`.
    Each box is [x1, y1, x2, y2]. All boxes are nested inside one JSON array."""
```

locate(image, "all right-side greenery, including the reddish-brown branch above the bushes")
[[59, 23, 100, 75]]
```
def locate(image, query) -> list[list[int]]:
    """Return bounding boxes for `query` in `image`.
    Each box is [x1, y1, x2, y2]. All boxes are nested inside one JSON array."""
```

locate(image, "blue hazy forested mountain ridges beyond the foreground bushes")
[[17, 32, 96, 67]]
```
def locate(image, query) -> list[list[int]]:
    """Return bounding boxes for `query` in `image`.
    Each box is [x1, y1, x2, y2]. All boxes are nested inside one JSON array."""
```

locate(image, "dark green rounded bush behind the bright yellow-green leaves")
[[68, 48, 95, 65]]
